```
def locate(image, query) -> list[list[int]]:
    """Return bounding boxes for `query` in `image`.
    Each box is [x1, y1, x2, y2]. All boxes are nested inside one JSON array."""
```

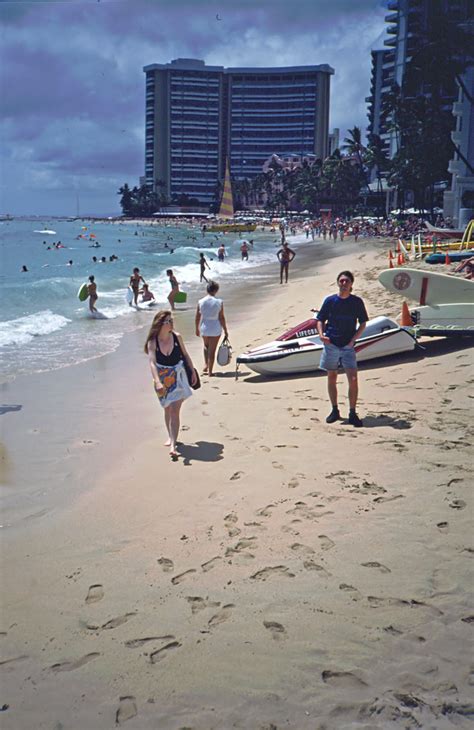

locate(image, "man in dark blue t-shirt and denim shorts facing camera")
[[316, 271, 369, 427]]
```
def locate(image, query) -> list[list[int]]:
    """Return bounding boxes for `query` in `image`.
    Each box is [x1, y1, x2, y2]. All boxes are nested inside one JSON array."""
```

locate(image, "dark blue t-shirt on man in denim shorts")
[[317, 294, 369, 347]]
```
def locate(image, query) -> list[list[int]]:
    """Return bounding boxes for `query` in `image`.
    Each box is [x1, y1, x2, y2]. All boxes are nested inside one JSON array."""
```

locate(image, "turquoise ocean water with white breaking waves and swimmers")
[[0, 219, 293, 380]]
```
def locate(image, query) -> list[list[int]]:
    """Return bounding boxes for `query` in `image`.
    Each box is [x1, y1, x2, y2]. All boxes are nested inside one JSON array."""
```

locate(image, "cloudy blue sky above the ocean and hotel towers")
[[0, 0, 386, 215]]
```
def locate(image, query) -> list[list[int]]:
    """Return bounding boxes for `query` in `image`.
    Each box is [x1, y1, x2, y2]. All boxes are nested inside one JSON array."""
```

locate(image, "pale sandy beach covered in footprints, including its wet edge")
[[0, 236, 474, 730]]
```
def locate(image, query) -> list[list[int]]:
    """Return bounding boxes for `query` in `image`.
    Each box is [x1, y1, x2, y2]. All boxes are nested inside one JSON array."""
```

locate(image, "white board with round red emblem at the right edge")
[[379, 266, 474, 306]]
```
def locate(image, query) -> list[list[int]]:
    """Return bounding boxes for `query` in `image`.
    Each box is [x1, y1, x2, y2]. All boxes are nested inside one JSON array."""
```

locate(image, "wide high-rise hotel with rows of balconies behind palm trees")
[[144, 58, 334, 204]]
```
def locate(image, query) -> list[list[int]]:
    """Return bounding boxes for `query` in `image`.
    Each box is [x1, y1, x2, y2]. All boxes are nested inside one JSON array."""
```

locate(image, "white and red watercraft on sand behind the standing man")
[[237, 317, 416, 375]]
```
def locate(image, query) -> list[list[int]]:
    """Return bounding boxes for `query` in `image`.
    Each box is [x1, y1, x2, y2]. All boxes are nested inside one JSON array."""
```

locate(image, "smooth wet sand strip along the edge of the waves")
[[0, 230, 366, 528]]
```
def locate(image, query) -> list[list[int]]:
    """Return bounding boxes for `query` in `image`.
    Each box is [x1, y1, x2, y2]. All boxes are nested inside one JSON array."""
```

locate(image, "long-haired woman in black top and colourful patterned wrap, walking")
[[145, 310, 196, 460]]
